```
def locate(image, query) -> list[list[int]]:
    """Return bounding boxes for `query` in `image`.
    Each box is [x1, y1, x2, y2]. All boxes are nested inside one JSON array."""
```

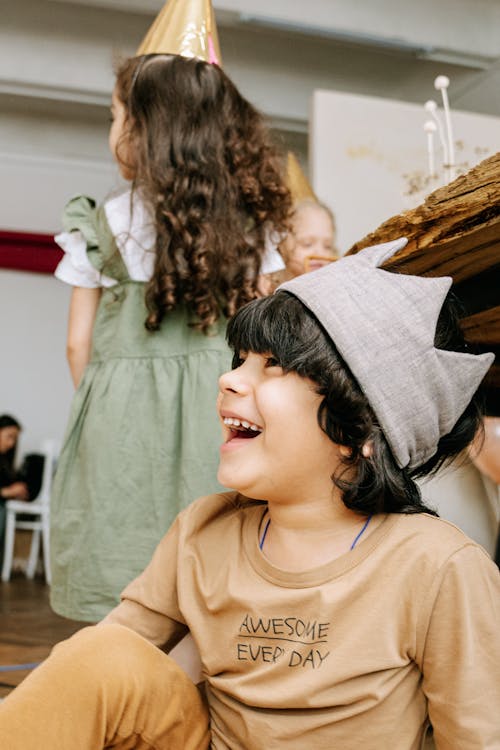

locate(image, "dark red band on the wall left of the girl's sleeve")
[[0, 231, 63, 273]]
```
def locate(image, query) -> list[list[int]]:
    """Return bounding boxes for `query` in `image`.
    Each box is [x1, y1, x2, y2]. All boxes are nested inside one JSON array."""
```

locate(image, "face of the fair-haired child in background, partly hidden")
[[280, 205, 334, 276]]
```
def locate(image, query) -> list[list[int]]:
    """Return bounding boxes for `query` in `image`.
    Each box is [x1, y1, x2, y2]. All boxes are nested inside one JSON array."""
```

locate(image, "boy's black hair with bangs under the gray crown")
[[227, 292, 481, 515]]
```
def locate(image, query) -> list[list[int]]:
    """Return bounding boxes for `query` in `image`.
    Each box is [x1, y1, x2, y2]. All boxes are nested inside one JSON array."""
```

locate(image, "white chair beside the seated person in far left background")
[[2, 440, 59, 584]]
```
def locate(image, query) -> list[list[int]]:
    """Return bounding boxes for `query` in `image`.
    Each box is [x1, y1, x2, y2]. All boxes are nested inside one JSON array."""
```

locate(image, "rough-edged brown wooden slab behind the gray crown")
[[348, 153, 500, 415]]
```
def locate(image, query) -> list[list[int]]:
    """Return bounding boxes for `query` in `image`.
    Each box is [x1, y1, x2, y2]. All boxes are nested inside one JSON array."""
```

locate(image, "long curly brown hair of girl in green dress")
[[115, 55, 291, 333]]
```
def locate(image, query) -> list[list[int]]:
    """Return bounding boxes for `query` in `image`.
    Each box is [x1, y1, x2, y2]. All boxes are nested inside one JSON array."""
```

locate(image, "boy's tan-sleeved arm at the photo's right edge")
[[421, 544, 500, 750]]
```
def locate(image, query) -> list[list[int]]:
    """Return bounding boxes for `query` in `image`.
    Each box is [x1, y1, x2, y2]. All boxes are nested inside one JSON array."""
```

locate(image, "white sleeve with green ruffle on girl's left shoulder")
[[54, 195, 116, 289]]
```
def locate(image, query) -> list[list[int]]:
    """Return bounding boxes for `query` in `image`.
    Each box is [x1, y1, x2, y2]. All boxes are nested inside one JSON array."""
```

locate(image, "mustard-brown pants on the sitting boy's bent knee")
[[0, 625, 210, 750]]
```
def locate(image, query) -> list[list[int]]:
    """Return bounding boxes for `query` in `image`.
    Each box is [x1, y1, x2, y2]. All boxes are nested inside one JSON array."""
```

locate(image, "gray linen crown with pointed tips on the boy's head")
[[276, 237, 494, 469]]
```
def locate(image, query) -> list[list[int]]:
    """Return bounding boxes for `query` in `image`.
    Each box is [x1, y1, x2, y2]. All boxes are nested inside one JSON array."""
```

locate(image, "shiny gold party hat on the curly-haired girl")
[[136, 0, 222, 66]]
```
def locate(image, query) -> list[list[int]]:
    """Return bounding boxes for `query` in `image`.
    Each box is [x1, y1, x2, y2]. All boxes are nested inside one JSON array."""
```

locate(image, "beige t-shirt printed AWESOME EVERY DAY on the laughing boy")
[[106, 493, 500, 750]]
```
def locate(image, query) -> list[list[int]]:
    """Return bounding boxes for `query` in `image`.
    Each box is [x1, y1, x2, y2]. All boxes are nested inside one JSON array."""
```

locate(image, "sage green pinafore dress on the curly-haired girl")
[[51, 199, 231, 622]]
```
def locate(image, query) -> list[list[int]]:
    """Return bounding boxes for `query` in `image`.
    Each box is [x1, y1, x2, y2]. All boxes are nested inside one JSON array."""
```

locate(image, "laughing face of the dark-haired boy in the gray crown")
[[218, 352, 339, 503]]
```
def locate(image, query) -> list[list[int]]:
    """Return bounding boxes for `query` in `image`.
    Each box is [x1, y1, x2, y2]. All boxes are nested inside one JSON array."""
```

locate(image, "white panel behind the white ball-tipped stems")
[[310, 89, 500, 252]]
